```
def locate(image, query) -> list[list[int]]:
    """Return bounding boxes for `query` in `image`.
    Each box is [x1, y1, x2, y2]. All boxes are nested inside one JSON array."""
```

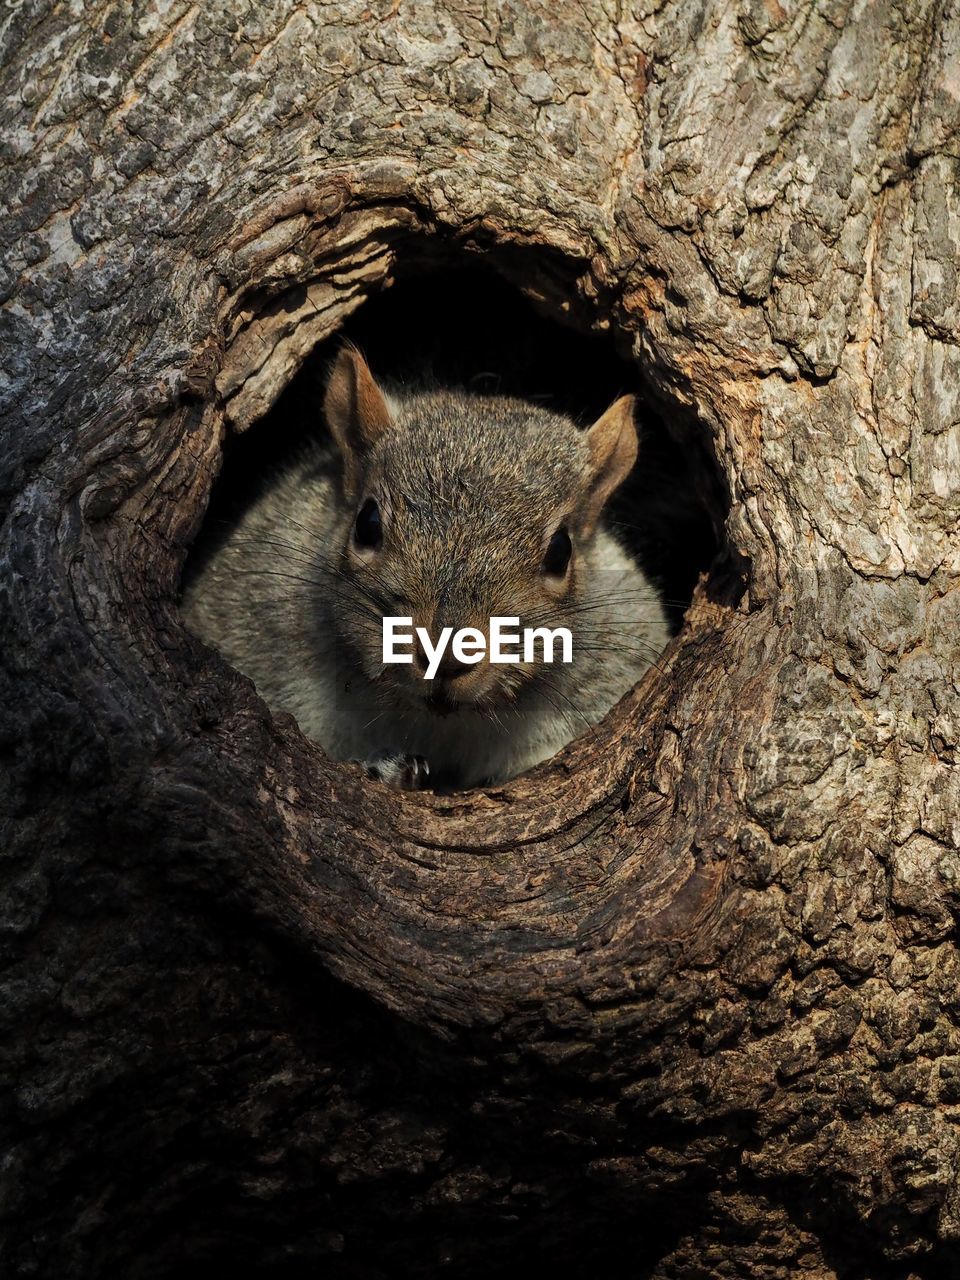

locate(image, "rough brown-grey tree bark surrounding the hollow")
[[0, 0, 960, 1280]]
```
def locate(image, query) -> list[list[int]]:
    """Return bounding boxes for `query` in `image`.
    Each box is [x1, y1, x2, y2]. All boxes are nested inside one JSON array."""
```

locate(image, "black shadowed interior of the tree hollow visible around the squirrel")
[[184, 268, 736, 788]]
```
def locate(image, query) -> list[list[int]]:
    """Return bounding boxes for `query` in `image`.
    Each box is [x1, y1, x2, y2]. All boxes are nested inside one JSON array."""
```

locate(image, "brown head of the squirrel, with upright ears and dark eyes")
[[324, 346, 637, 713]]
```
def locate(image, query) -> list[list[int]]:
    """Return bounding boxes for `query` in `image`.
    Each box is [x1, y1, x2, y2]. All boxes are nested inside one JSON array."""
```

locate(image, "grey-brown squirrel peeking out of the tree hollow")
[[182, 346, 668, 790]]
